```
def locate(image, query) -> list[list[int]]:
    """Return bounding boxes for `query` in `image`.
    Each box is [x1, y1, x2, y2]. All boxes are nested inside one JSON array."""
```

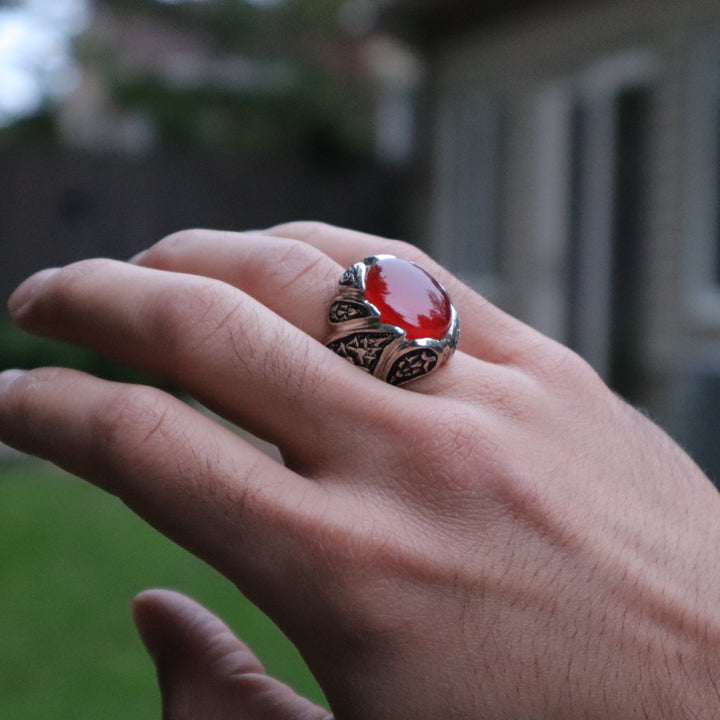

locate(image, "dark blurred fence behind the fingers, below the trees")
[[0, 150, 399, 298]]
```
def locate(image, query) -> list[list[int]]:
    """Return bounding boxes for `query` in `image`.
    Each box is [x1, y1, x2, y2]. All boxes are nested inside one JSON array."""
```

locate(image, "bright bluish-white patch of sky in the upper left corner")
[[0, 0, 283, 127]]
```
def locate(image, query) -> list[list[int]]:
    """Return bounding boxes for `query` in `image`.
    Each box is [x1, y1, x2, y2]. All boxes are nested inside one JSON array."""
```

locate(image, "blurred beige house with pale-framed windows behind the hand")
[[386, 0, 720, 479]]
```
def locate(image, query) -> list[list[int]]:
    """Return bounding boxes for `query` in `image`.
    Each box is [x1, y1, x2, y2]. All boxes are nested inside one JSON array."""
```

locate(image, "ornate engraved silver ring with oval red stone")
[[326, 255, 460, 385]]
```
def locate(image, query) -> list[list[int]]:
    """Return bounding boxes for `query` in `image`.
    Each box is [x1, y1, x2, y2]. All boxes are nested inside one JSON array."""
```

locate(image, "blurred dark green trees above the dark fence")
[[1, 0, 373, 159]]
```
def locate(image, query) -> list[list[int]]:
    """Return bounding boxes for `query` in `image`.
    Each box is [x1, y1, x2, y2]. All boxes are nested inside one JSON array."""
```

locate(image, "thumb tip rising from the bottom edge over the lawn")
[[133, 590, 332, 720]]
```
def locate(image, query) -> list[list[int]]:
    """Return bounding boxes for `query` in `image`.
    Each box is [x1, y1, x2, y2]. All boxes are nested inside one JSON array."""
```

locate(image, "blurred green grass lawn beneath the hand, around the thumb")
[[0, 460, 322, 720]]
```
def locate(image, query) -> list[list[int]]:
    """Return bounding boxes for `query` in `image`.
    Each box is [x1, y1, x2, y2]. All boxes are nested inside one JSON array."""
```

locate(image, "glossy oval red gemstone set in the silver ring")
[[365, 258, 452, 340]]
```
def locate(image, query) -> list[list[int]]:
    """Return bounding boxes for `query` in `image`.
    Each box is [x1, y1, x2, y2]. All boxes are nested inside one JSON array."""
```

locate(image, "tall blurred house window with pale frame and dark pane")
[[536, 51, 655, 397]]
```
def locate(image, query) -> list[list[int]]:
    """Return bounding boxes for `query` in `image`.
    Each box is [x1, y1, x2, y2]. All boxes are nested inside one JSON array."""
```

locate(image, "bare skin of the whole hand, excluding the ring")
[[0, 223, 720, 720]]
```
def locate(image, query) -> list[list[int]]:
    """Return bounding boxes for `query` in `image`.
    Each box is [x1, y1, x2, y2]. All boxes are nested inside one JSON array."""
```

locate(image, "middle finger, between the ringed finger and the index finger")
[[5, 260, 391, 472]]
